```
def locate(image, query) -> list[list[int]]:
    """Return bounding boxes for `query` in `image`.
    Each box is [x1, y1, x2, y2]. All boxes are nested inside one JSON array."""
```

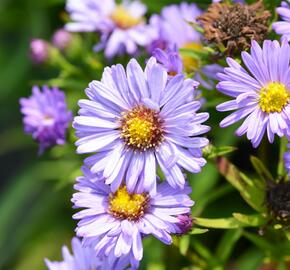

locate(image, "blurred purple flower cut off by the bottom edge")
[[45, 237, 129, 270]]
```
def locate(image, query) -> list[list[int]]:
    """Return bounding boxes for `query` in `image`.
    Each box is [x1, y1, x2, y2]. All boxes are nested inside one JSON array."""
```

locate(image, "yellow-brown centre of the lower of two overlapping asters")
[[109, 186, 149, 221]]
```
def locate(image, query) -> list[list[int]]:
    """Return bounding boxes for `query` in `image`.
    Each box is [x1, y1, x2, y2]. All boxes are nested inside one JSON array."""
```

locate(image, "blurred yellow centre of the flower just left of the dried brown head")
[[181, 42, 203, 73]]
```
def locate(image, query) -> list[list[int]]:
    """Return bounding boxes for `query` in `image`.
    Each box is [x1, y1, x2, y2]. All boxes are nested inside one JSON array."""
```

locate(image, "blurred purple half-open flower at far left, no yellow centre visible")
[[20, 86, 72, 153]]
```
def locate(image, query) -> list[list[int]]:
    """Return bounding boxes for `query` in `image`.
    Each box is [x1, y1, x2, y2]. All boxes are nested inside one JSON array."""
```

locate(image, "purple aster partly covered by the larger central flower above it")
[[72, 168, 193, 267]]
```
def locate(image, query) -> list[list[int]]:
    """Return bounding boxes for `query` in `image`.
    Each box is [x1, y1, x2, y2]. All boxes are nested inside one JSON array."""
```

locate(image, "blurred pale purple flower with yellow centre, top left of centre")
[[66, 0, 154, 58]]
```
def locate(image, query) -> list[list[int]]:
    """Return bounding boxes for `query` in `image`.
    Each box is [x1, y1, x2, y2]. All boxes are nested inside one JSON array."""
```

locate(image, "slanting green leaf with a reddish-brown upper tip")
[[217, 157, 267, 212]]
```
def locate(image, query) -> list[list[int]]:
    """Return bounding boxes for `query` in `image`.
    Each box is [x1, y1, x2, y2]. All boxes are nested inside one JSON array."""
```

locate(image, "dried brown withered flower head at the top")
[[198, 1, 271, 55]]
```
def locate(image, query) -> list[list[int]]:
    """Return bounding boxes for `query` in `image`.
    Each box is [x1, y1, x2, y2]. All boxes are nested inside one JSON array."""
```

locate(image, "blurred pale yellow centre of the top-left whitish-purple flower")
[[111, 5, 143, 29]]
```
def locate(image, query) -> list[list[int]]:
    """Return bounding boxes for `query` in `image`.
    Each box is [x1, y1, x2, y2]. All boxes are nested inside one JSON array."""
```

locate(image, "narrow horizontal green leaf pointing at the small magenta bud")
[[194, 217, 246, 229]]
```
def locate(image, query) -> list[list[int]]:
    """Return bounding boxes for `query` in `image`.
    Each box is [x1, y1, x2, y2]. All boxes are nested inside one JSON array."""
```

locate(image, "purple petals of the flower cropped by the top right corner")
[[272, 0, 290, 41]]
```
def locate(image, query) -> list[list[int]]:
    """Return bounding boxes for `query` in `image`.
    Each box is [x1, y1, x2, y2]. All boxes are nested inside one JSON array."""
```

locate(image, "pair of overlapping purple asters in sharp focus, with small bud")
[[73, 53, 209, 268]]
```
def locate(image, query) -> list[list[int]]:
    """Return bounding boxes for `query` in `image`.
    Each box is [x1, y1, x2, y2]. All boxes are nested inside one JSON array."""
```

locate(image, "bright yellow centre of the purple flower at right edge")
[[259, 82, 290, 113]]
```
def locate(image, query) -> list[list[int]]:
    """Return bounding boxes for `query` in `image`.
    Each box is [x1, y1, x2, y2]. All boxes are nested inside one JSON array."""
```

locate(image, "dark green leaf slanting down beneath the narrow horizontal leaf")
[[216, 229, 242, 264]]
